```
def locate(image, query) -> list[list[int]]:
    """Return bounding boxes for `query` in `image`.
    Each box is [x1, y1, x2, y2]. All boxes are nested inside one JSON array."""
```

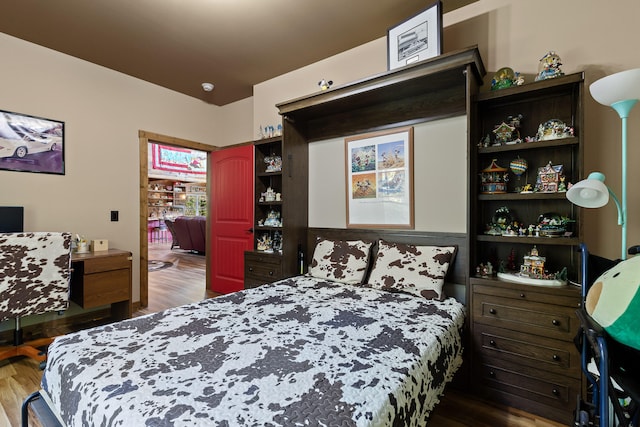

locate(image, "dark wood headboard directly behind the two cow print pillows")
[[306, 227, 469, 285]]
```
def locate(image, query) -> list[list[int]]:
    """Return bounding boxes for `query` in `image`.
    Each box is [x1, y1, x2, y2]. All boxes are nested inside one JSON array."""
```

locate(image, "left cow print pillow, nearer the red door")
[[309, 238, 373, 285]]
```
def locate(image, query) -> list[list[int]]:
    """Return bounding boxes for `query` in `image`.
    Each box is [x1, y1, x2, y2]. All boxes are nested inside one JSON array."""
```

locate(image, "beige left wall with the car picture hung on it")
[[0, 33, 252, 308]]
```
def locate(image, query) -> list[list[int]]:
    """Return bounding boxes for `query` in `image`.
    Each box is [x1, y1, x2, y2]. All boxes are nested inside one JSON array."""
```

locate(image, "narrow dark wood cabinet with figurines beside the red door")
[[244, 136, 309, 288]]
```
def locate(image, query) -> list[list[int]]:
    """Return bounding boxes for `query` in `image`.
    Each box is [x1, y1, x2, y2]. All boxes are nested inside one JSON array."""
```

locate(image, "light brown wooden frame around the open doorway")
[[134, 130, 220, 311]]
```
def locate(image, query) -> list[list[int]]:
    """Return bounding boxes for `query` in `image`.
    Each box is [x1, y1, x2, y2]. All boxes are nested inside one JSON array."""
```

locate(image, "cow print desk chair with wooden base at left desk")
[[0, 232, 71, 367]]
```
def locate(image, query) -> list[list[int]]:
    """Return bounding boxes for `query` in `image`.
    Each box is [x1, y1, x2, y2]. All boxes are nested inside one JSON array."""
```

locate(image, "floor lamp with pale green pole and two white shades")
[[567, 68, 640, 260]]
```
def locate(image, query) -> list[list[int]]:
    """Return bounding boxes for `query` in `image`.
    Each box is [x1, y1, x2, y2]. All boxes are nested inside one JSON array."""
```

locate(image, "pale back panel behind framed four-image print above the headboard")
[[309, 116, 467, 233]]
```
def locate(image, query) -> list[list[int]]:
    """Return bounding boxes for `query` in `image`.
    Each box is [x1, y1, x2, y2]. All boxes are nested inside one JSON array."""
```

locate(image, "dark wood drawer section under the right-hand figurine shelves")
[[471, 278, 581, 424]]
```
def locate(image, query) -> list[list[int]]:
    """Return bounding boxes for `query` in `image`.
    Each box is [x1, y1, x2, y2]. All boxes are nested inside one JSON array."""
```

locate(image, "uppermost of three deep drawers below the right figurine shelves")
[[473, 293, 579, 341]]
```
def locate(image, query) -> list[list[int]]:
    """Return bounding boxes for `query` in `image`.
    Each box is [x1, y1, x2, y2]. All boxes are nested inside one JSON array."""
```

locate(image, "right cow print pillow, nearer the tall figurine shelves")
[[369, 240, 457, 300]]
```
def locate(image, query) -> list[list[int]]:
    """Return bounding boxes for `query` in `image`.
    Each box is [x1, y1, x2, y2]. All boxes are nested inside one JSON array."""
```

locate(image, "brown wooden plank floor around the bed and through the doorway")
[[0, 244, 563, 427]]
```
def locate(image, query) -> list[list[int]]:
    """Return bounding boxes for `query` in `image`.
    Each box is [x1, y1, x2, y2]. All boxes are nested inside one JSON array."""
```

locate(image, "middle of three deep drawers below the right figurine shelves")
[[473, 324, 581, 380]]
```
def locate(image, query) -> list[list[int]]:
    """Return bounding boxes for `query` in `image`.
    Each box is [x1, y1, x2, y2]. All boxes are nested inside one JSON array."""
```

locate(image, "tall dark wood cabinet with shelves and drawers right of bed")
[[469, 73, 584, 423]]
